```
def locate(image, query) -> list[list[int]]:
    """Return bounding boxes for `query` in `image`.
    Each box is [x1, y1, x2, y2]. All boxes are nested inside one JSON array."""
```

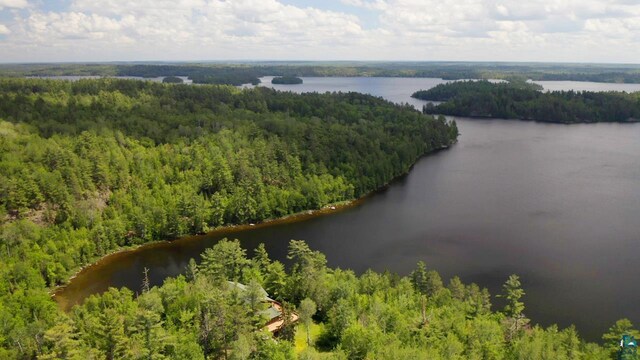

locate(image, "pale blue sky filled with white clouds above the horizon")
[[0, 0, 640, 64]]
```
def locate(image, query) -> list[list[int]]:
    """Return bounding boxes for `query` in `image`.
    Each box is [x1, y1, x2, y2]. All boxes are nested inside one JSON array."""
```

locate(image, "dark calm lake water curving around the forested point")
[[58, 78, 640, 340]]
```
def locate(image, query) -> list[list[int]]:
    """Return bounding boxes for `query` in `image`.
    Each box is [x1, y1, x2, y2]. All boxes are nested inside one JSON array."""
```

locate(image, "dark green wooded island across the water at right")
[[412, 81, 640, 124]]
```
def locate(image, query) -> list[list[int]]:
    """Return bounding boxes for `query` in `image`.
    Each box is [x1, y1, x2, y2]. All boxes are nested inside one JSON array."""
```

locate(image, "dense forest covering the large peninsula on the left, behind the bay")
[[0, 79, 458, 359]]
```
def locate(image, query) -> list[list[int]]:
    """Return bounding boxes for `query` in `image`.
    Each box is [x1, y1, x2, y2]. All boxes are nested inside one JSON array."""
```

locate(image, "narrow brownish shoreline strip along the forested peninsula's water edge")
[[49, 140, 457, 312]]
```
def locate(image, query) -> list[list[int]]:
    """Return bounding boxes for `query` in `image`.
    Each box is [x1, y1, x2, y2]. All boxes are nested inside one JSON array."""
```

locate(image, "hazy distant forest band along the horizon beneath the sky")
[[0, 61, 640, 85]]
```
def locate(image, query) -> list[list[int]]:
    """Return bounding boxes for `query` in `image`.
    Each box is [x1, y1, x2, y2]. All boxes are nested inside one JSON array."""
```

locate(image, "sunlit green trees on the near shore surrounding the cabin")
[[21, 240, 638, 360]]
